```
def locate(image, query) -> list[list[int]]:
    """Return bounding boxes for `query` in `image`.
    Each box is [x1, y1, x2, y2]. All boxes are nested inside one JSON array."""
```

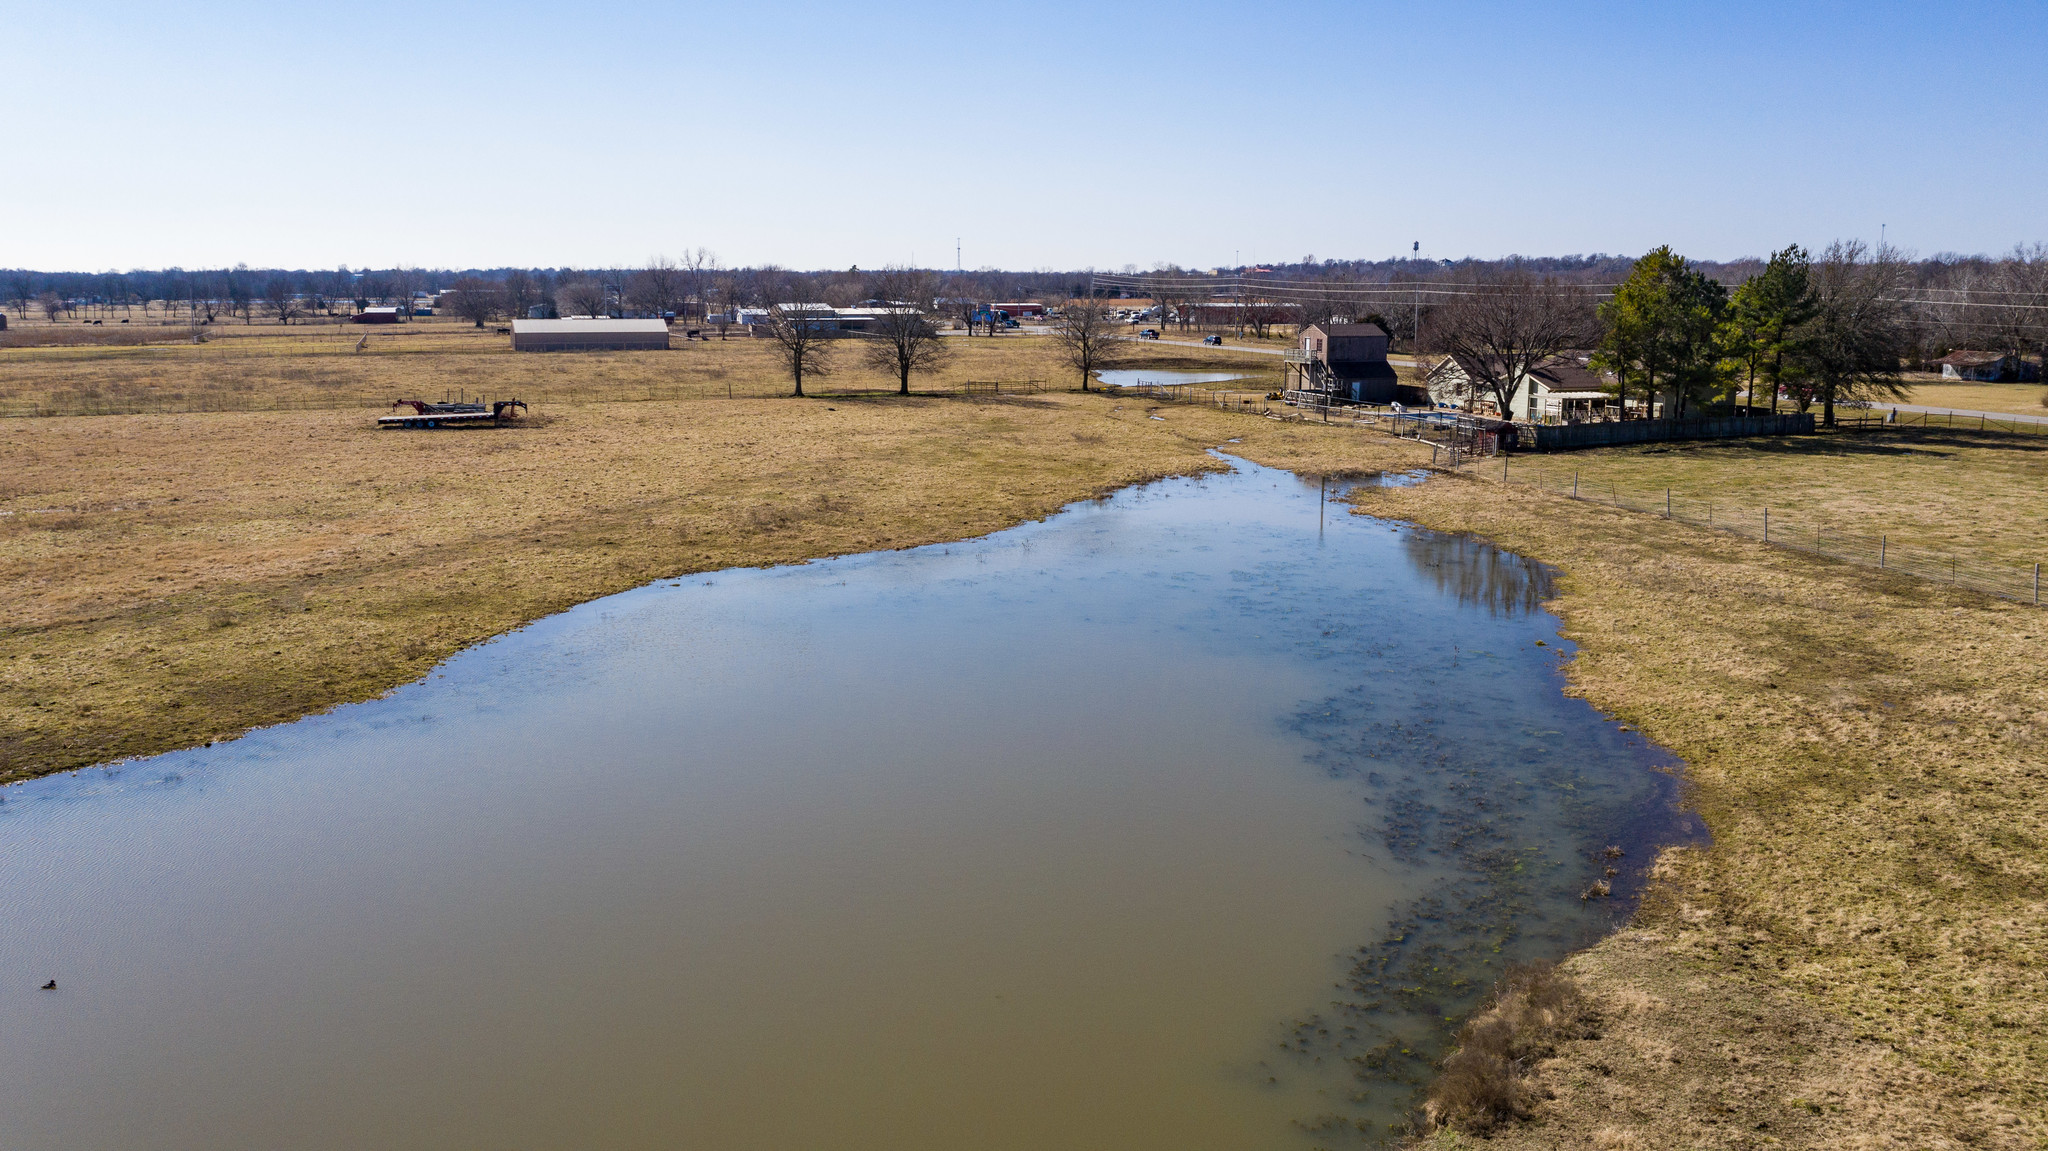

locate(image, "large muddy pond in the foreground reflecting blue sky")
[[0, 456, 1690, 1151]]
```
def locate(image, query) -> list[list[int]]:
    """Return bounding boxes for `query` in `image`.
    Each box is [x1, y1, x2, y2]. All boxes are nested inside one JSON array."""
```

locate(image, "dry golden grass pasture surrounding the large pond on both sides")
[[0, 324, 2048, 1149]]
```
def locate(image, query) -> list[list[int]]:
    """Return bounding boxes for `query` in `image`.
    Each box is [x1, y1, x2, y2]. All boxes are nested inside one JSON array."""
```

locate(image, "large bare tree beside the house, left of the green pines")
[[1430, 266, 1597, 418]]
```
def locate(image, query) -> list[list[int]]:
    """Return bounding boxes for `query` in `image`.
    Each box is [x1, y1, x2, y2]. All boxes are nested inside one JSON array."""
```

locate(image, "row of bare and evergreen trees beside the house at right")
[[1421, 240, 2048, 424]]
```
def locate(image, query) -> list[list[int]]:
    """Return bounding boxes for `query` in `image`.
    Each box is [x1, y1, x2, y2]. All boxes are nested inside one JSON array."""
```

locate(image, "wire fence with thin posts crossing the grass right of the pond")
[[1464, 457, 2042, 606]]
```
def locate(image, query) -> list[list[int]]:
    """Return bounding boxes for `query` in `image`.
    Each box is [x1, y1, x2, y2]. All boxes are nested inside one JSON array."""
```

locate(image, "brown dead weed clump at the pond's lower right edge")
[[1421, 963, 1593, 1135]]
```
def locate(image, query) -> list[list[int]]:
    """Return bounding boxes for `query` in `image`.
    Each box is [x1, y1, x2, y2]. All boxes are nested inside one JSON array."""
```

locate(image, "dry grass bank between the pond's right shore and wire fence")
[[1360, 462, 2048, 1151]]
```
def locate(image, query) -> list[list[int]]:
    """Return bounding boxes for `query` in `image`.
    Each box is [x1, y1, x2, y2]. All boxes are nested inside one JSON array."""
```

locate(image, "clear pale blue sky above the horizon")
[[0, 0, 2048, 270]]
